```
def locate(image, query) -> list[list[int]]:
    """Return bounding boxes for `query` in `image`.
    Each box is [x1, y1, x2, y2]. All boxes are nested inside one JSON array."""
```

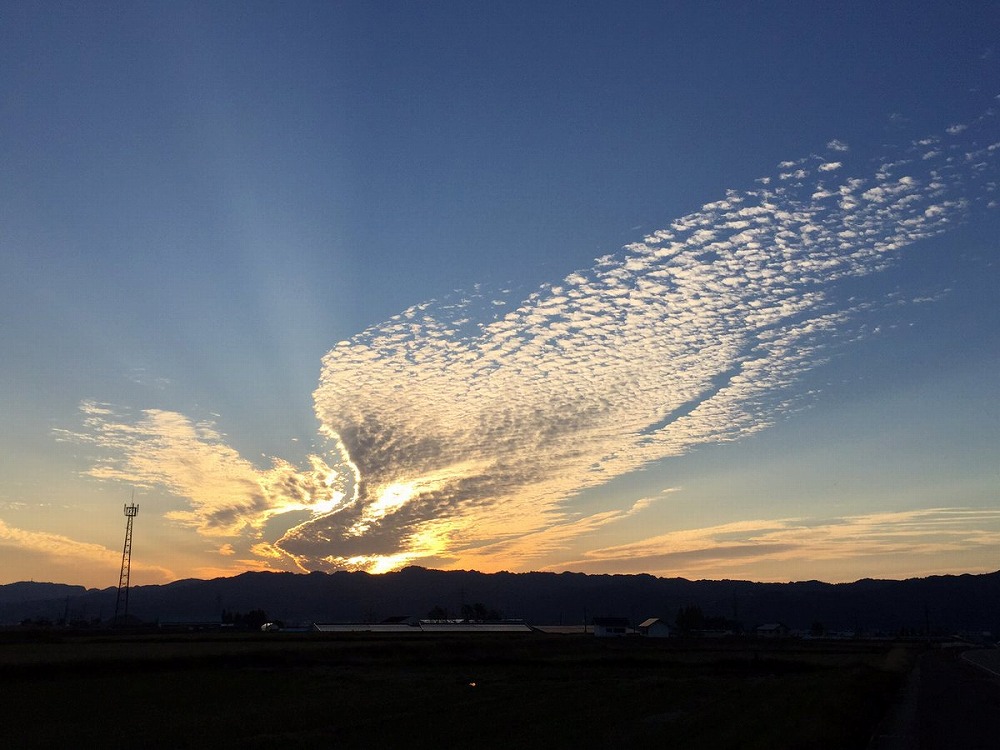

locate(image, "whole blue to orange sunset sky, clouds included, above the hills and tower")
[[0, 0, 1000, 588]]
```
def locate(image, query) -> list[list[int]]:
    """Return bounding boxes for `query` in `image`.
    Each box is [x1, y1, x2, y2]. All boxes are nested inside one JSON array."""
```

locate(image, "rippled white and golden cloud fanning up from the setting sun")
[[68, 108, 1000, 571]]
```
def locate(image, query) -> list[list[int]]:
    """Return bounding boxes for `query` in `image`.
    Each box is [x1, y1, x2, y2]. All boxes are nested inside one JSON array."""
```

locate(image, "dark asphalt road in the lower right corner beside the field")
[[869, 649, 1000, 750]]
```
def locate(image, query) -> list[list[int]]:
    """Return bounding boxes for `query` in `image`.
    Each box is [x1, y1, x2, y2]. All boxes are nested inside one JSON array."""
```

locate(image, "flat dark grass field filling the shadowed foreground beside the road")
[[0, 633, 914, 750]]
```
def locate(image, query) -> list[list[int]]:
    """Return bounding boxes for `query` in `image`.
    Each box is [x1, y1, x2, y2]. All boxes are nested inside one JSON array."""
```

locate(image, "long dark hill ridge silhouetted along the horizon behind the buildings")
[[0, 567, 1000, 633]]
